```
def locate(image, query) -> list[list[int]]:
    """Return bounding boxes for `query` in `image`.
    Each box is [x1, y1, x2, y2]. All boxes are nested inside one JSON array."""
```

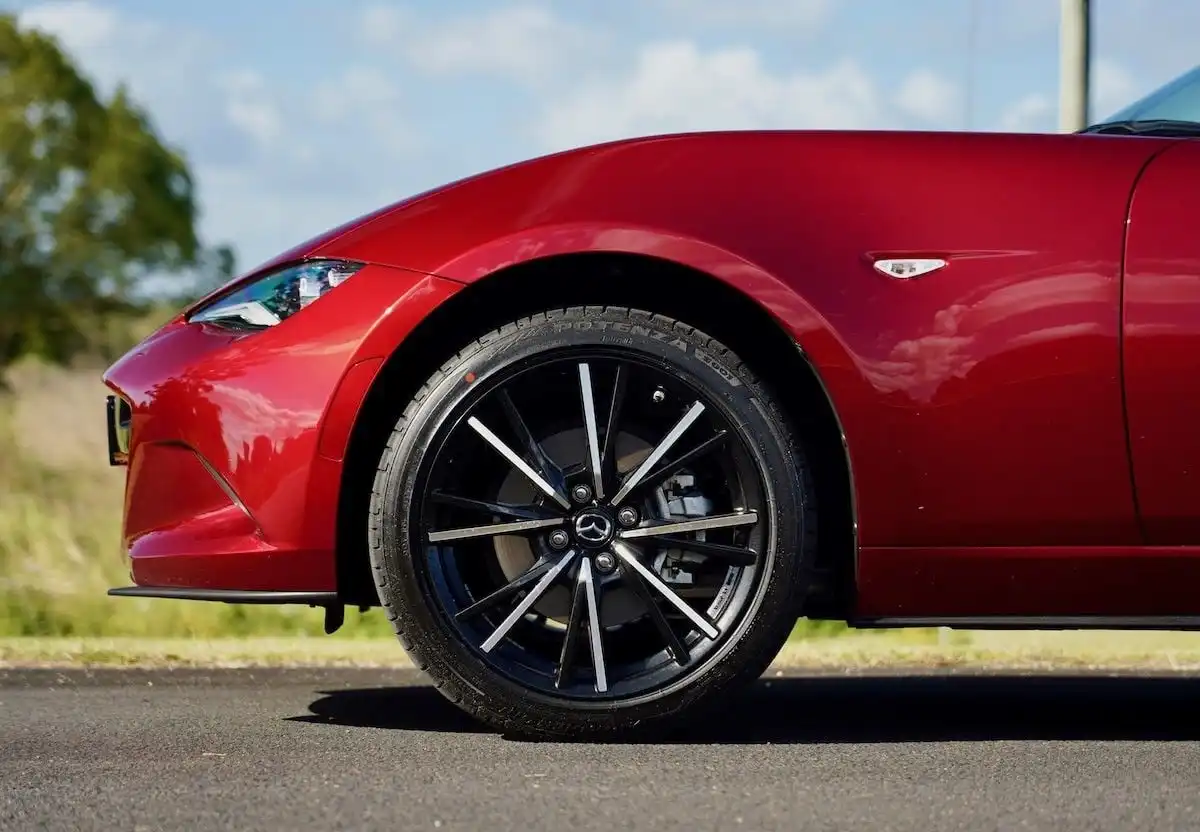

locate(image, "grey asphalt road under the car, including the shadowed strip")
[[0, 670, 1200, 832]]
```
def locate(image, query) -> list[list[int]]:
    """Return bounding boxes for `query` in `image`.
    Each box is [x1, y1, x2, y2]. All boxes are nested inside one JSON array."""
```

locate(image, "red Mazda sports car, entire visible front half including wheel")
[[104, 64, 1200, 737]]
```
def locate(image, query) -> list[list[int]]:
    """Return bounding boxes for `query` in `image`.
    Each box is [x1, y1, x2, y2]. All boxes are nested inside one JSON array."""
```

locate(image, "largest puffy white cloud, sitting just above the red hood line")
[[536, 41, 883, 148]]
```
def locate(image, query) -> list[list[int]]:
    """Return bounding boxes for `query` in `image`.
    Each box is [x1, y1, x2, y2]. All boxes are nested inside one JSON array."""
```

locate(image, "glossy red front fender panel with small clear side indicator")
[[322, 132, 1153, 547]]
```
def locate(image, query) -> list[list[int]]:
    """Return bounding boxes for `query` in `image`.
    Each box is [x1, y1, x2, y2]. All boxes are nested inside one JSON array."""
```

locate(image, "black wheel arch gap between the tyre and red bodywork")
[[337, 251, 857, 618]]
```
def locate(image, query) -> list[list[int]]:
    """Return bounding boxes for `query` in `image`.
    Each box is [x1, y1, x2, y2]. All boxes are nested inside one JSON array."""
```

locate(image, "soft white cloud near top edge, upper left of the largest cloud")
[[361, 5, 595, 82]]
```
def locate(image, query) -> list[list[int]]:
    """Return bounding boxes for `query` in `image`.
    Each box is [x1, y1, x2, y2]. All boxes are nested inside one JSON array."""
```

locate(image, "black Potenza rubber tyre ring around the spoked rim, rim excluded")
[[371, 309, 808, 736]]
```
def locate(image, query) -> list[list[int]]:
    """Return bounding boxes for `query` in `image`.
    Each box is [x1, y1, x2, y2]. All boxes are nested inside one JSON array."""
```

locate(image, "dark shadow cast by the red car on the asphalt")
[[292, 674, 1200, 744]]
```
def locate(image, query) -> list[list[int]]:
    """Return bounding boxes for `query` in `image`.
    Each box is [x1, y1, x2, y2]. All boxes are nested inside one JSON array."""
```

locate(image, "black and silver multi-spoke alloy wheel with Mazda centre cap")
[[410, 348, 769, 700]]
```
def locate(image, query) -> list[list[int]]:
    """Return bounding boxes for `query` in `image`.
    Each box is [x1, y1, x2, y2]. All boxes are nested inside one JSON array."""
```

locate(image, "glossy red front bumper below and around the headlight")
[[104, 267, 460, 593]]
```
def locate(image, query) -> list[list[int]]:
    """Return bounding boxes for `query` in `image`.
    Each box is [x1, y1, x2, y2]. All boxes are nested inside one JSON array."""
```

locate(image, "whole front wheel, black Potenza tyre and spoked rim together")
[[370, 306, 816, 740]]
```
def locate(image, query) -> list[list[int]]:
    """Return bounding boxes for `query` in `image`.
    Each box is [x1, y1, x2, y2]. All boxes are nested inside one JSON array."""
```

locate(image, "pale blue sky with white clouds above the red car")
[[0, 0, 1200, 268]]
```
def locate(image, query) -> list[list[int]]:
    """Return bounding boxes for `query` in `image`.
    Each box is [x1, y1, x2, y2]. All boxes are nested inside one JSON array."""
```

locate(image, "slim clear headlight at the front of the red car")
[[188, 261, 362, 329]]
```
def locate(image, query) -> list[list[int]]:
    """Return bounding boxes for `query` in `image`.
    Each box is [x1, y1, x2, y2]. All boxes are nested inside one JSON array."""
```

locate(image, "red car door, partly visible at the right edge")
[[1122, 139, 1200, 546]]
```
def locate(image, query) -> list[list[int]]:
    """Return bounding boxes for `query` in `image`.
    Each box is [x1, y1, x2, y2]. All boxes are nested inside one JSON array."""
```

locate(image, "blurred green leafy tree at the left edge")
[[0, 14, 234, 372]]
